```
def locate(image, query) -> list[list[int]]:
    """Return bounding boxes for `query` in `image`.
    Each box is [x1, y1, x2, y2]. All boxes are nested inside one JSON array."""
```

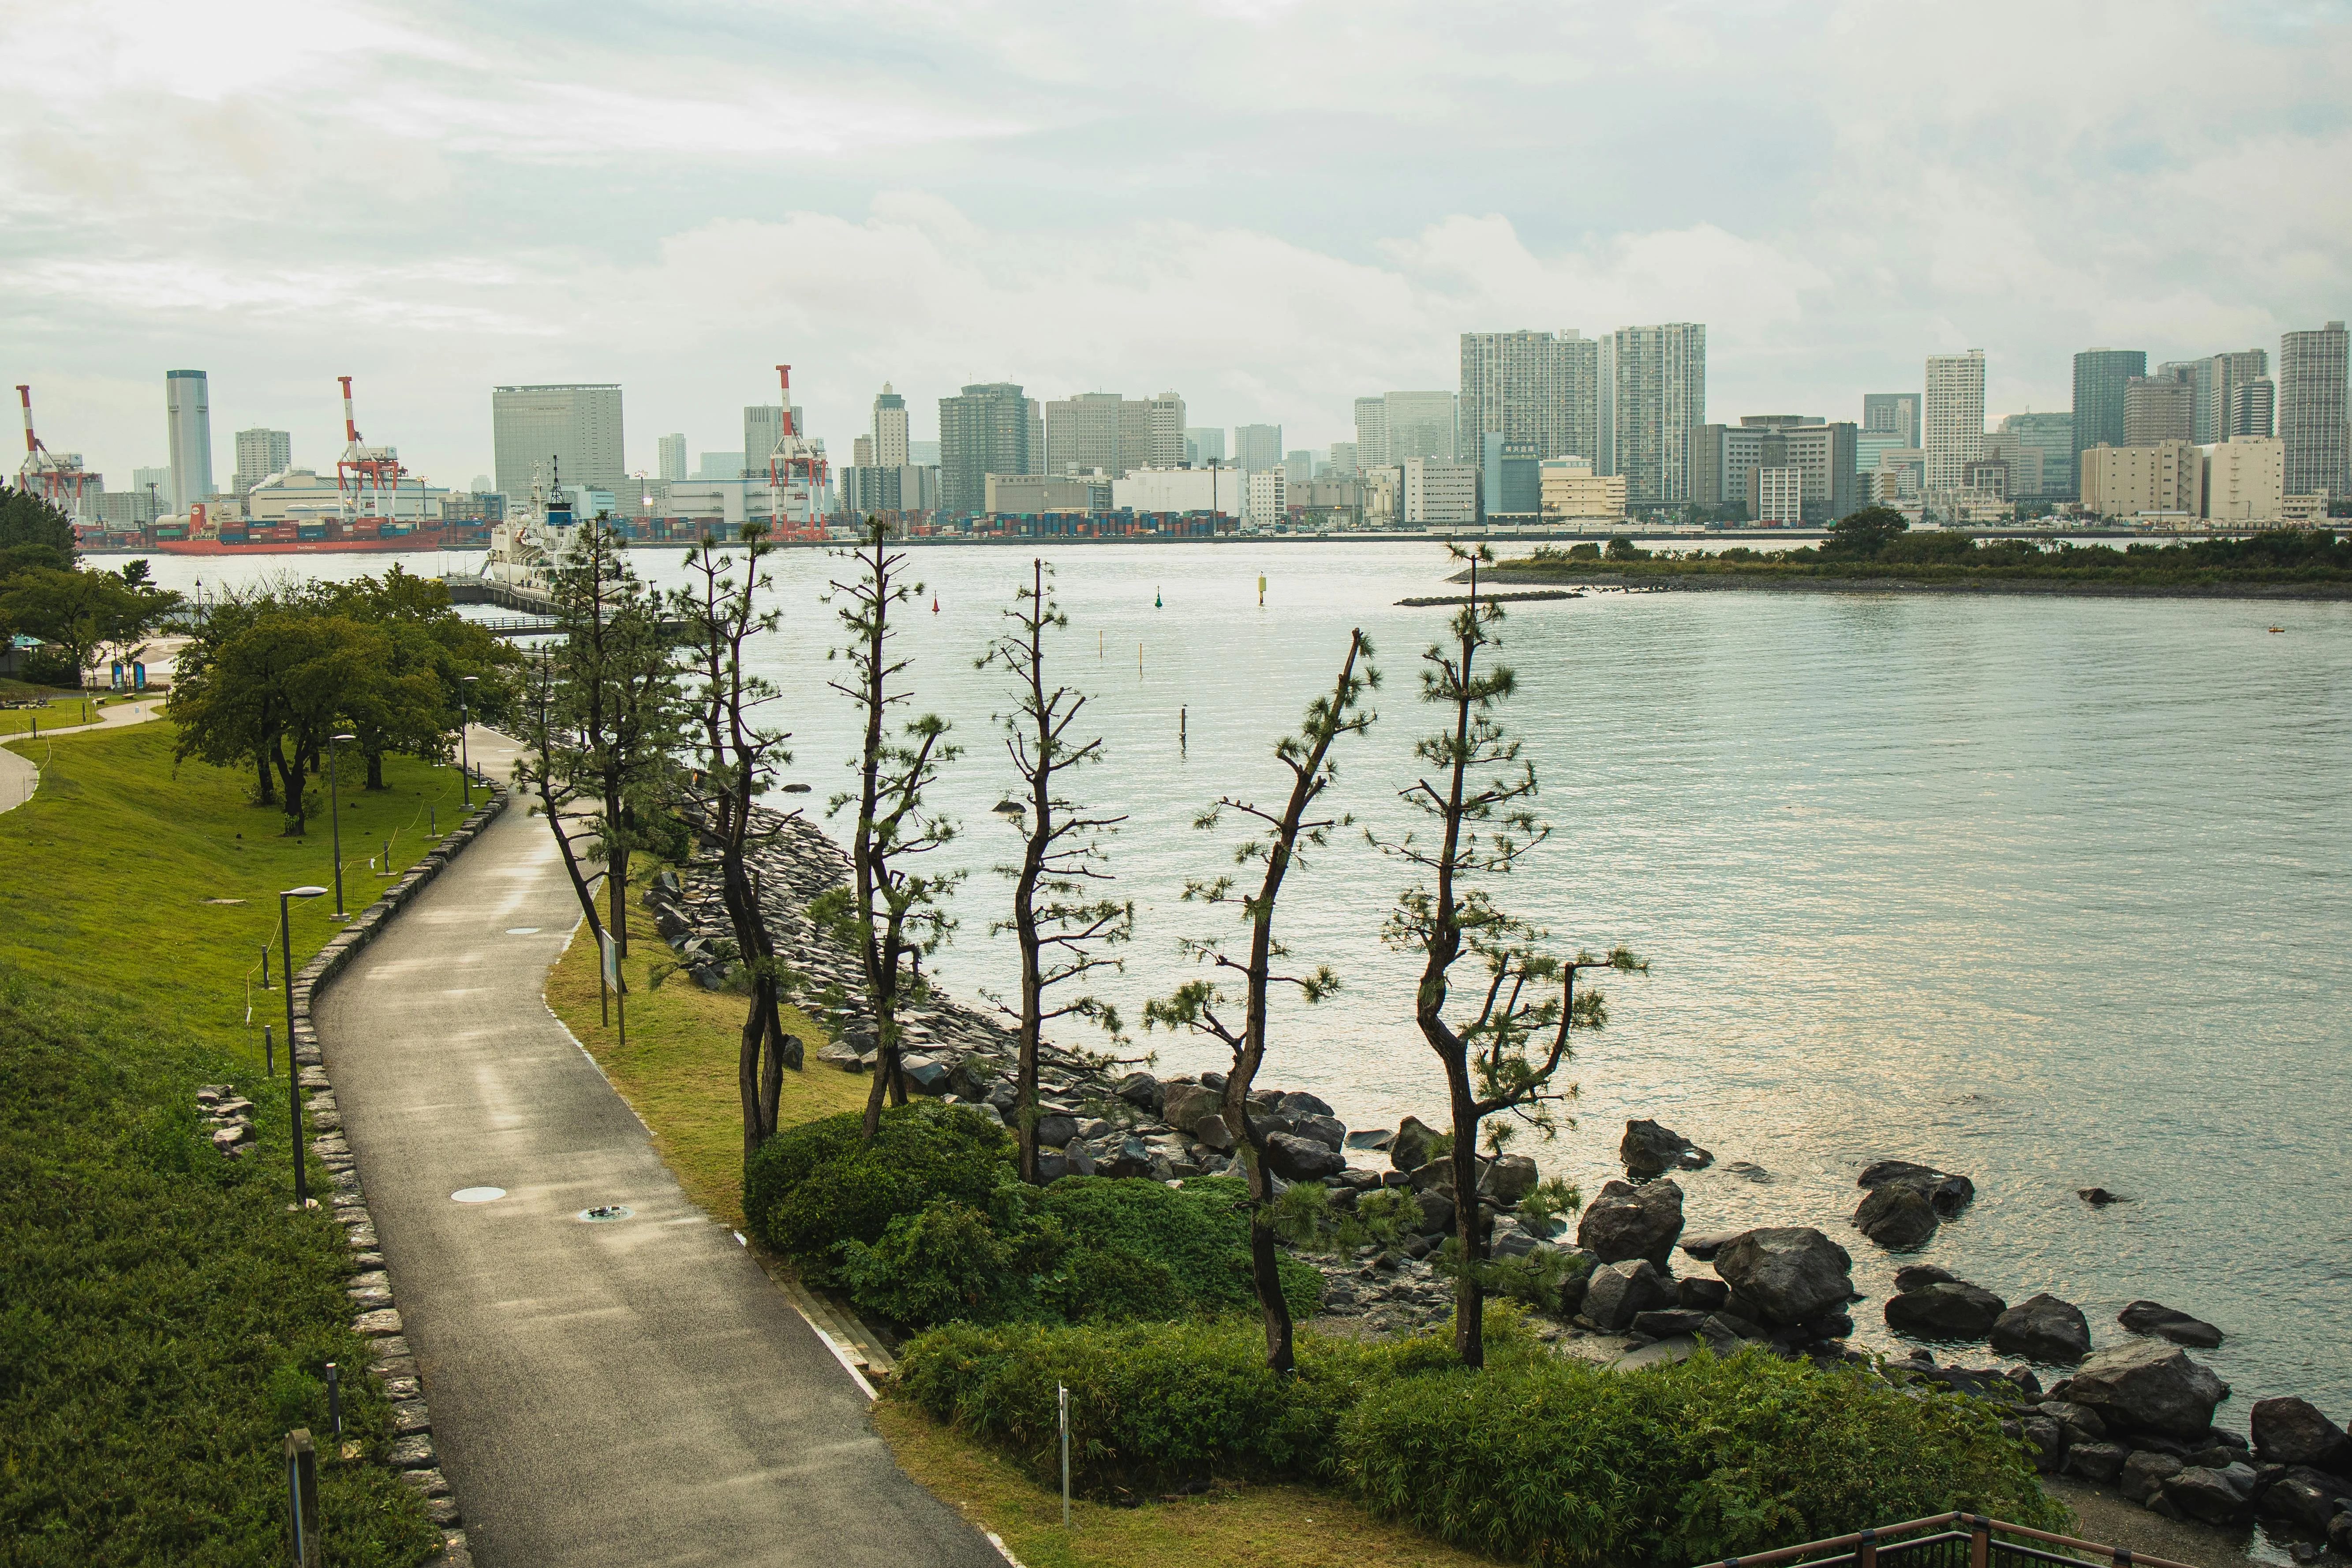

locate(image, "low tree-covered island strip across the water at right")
[[1456, 508, 2352, 599]]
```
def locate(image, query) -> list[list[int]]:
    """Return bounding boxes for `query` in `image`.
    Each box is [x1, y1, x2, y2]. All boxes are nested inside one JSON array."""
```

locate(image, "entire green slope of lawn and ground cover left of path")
[[0, 724, 456, 1568]]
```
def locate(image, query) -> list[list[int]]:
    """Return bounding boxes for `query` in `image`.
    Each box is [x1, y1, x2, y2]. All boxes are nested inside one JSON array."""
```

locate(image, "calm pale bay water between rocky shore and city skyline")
[[137, 543, 2352, 1427]]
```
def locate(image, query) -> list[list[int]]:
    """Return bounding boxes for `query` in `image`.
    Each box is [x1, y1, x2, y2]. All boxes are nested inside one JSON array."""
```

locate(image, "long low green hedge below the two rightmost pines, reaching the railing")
[[894, 1310, 2065, 1568]]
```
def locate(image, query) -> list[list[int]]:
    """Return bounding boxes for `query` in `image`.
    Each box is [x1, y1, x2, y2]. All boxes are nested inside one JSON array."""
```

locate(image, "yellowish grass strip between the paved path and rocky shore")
[[548, 865, 1486, 1568]]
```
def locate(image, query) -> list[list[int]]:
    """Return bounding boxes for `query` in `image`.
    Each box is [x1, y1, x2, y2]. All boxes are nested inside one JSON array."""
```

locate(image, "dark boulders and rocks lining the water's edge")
[[644, 811, 2352, 1556]]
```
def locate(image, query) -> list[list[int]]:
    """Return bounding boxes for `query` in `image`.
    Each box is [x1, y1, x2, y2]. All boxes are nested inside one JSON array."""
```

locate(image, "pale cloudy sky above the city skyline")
[[0, 0, 2352, 484]]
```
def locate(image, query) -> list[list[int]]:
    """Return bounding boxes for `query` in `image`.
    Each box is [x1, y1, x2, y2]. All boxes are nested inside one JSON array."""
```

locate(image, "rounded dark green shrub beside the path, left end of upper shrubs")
[[743, 1100, 1014, 1284]]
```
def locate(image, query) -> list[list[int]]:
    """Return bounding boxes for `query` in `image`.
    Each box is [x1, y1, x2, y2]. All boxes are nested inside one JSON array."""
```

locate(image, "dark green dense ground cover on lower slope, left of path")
[[0, 966, 440, 1568]]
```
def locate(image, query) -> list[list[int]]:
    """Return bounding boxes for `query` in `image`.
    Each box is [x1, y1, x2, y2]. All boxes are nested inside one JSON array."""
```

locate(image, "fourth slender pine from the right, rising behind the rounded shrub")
[[809, 517, 962, 1142]]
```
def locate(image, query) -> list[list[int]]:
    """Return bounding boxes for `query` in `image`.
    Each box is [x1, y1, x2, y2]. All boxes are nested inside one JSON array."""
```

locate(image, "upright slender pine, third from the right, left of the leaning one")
[[981, 560, 1136, 1183]]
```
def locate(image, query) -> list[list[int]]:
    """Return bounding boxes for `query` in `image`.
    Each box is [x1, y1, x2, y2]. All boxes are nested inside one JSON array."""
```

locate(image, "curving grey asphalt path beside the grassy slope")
[[318, 731, 1004, 1568]]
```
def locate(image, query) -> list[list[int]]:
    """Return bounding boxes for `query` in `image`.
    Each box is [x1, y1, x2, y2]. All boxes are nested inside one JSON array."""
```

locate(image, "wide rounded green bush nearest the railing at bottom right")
[[1331, 1349, 2068, 1568]]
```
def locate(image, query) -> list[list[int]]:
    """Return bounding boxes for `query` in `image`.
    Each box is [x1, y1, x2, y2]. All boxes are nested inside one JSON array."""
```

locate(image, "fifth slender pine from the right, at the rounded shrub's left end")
[[670, 522, 802, 1164]]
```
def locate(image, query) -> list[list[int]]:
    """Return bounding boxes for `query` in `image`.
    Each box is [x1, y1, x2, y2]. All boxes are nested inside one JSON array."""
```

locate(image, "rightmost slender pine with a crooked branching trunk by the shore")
[[1380, 546, 1646, 1366]]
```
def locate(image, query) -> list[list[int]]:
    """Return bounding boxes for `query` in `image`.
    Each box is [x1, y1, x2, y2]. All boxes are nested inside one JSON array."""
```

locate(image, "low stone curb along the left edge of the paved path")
[[292, 781, 508, 1568]]
